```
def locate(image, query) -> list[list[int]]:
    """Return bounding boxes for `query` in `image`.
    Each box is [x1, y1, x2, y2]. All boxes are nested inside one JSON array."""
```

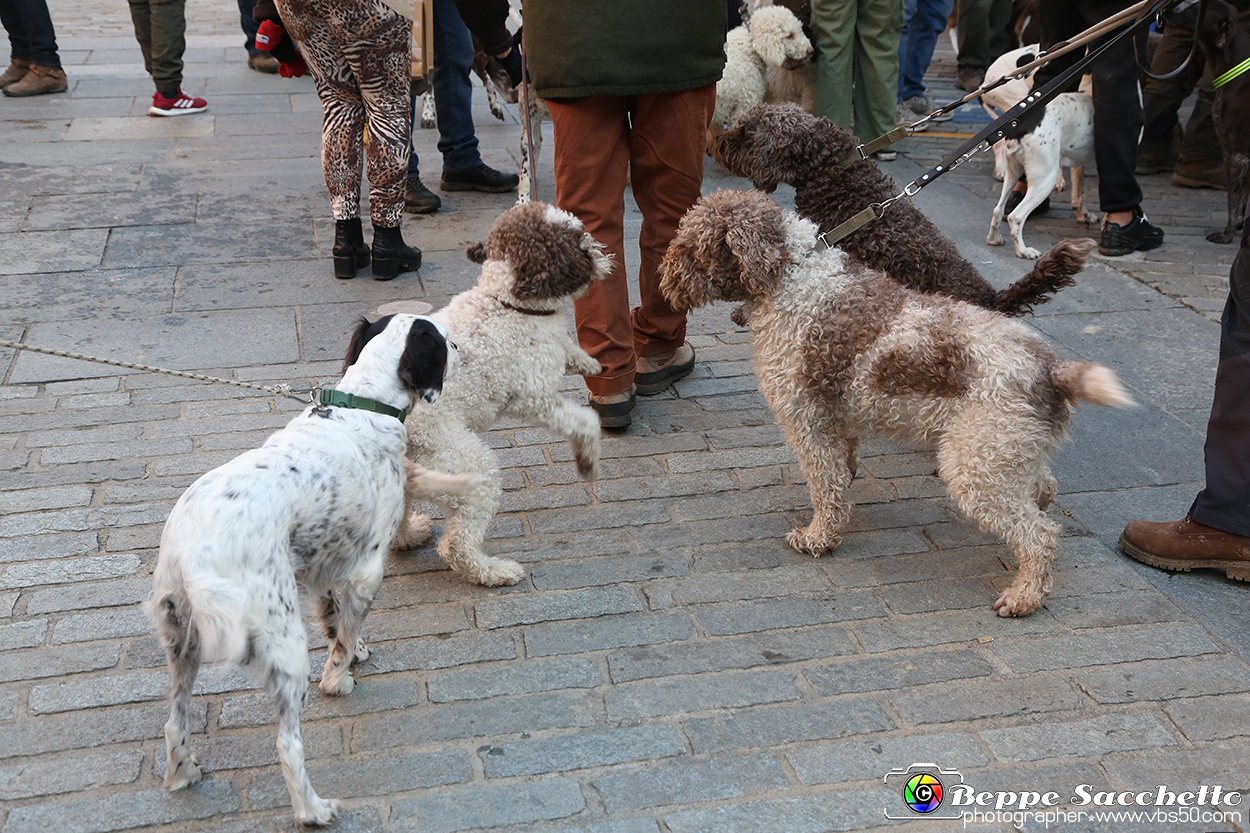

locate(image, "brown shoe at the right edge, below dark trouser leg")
[[1120, 515, 1250, 582]]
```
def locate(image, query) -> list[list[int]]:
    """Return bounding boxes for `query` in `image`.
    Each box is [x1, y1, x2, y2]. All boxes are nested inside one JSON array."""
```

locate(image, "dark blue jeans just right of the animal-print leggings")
[[407, 0, 481, 176]]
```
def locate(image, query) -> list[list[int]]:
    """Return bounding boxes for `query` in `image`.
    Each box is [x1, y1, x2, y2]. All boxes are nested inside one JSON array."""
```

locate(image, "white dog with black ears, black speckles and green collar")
[[148, 315, 474, 824]]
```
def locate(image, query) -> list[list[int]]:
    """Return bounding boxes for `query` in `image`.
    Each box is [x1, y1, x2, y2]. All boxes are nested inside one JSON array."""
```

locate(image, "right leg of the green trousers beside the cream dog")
[[853, 0, 903, 150]]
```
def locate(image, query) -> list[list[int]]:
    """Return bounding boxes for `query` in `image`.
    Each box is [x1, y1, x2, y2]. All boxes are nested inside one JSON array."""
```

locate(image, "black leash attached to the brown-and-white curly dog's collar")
[[820, 0, 1178, 248]]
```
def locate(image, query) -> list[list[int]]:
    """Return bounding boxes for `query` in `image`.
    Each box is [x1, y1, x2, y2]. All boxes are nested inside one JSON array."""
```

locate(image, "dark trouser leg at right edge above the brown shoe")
[[1190, 207, 1250, 537]]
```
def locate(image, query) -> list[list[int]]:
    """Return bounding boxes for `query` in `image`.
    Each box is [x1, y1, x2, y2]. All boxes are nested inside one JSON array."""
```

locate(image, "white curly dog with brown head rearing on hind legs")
[[396, 203, 611, 585]]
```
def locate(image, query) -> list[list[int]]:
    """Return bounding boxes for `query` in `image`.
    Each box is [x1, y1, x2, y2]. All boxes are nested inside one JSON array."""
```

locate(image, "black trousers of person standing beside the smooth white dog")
[[1033, 0, 1146, 213]]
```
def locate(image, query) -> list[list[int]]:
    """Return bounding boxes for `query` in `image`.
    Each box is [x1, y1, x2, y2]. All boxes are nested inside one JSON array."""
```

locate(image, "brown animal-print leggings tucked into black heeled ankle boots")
[[276, 0, 413, 228]]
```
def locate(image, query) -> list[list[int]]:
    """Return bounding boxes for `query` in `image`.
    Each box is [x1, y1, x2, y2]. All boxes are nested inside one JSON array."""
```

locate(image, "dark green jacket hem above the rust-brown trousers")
[[524, 0, 728, 99]]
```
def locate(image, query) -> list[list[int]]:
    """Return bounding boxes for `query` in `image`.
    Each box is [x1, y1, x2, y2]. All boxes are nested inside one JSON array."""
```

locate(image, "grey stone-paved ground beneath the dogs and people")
[[0, 0, 1250, 833]]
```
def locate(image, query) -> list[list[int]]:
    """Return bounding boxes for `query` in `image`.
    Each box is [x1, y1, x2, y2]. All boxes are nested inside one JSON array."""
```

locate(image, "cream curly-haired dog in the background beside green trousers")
[[708, 6, 811, 141]]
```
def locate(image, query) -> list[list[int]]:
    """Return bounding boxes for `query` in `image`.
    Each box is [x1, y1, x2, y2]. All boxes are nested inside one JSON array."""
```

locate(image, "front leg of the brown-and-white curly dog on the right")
[[783, 424, 859, 557]]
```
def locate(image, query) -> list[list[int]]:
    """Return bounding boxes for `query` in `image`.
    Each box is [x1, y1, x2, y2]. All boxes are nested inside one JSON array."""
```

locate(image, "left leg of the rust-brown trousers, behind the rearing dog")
[[546, 95, 636, 395]]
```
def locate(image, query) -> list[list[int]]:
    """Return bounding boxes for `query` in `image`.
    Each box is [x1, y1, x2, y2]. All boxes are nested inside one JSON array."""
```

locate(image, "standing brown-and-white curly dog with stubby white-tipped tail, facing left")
[[660, 191, 1131, 617]]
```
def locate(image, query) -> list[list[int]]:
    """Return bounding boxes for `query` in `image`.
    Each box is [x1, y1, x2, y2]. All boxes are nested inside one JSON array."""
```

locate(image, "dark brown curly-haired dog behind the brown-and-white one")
[[713, 104, 1093, 315]]
